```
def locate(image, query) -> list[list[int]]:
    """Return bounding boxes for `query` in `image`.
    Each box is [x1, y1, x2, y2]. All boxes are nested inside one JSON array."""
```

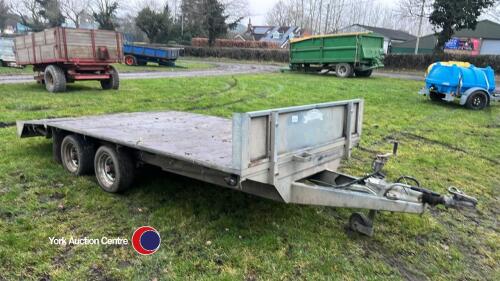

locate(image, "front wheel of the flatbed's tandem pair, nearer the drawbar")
[[94, 145, 135, 193]]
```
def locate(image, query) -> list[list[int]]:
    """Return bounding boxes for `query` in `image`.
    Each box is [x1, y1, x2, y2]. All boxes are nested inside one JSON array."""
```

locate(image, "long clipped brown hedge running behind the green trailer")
[[183, 46, 500, 70]]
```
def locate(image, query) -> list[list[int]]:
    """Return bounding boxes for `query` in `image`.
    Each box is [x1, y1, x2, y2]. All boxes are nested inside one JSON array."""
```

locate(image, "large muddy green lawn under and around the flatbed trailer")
[[0, 73, 500, 280]]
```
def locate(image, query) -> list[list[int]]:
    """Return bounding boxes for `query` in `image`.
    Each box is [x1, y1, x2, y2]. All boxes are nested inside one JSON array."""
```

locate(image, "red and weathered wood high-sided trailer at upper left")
[[15, 27, 123, 92]]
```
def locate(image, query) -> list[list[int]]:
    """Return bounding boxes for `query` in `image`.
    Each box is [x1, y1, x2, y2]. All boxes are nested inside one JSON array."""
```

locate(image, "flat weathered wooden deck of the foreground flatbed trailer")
[[18, 111, 239, 174]]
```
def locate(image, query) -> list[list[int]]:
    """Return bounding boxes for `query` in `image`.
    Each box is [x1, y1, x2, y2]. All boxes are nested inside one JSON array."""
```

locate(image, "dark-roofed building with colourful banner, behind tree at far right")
[[392, 20, 500, 55]]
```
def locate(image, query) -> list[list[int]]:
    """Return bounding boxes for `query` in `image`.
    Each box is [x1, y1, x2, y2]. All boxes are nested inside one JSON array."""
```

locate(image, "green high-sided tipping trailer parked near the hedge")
[[290, 32, 384, 77]]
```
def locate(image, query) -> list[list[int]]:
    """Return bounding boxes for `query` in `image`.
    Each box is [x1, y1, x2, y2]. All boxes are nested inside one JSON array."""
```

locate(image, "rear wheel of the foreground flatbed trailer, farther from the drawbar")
[[61, 135, 94, 176]]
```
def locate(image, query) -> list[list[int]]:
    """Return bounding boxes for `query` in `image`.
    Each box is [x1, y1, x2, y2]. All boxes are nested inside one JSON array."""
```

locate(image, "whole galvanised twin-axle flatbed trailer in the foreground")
[[17, 100, 475, 235]]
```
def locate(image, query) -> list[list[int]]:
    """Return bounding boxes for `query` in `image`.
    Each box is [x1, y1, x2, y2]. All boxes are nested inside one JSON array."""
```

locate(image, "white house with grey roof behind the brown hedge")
[[235, 19, 302, 48]]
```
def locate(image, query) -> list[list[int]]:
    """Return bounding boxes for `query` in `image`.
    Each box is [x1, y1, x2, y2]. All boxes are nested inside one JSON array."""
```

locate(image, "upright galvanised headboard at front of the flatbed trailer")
[[232, 100, 363, 188]]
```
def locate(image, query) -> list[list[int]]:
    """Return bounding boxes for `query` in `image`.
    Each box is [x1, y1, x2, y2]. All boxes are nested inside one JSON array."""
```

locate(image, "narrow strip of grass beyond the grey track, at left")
[[0, 58, 215, 75]]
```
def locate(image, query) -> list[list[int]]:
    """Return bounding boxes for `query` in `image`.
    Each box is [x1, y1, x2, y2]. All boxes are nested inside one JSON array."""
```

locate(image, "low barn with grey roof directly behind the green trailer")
[[339, 24, 417, 53]]
